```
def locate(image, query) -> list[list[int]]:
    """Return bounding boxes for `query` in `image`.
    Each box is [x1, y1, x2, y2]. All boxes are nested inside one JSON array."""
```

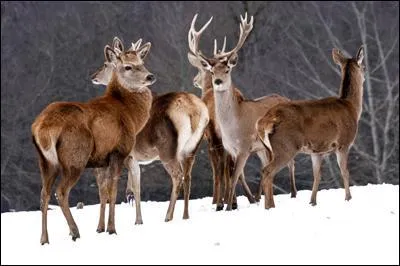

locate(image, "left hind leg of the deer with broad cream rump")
[[164, 160, 183, 222]]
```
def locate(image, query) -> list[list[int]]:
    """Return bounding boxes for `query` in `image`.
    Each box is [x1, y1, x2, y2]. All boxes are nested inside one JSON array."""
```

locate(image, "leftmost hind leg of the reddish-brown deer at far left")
[[39, 158, 58, 245]]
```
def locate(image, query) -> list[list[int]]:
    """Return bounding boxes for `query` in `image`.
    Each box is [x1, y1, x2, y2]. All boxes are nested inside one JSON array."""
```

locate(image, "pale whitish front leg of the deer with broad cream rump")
[[125, 156, 143, 224]]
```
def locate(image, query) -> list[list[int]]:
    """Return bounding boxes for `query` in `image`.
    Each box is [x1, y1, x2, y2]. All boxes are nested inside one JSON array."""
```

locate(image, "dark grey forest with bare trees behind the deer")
[[1, 1, 399, 212]]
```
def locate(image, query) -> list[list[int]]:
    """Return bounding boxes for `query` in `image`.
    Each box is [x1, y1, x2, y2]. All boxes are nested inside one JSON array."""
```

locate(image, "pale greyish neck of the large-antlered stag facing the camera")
[[214, 77, 239, 129]]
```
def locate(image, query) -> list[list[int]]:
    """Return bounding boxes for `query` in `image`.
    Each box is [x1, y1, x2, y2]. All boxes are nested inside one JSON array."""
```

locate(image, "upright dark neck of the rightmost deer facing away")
[[339, 64, 363, 119]]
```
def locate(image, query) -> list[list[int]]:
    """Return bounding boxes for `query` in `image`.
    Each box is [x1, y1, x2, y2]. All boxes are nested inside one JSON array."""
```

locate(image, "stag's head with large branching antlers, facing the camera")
[[188, 13, 254, 91]]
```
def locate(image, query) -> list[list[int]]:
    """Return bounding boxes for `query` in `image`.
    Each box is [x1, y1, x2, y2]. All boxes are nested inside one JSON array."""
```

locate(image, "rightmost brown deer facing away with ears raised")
[[258, 46, 364, 209]]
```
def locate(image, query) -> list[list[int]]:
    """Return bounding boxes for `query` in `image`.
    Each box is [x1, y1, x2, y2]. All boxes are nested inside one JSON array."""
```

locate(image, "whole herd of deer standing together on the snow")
[[32, 14, 364, 244]]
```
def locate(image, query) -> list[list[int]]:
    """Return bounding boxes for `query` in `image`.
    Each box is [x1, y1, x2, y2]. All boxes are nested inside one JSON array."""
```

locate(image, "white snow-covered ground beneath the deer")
[[1, 184, 399, 265]]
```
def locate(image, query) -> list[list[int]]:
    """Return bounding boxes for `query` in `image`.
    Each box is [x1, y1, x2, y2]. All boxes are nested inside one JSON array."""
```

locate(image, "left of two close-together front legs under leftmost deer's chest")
[[94, 167, 110, 233]]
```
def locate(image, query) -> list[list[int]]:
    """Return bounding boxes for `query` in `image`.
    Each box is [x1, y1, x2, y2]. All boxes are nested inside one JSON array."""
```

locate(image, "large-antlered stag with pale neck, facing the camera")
[[188, 13, 297, 211]]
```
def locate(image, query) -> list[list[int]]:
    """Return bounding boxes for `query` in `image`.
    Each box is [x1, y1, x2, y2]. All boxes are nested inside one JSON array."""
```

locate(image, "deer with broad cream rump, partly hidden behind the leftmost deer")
[[92, 37, 209, 222]]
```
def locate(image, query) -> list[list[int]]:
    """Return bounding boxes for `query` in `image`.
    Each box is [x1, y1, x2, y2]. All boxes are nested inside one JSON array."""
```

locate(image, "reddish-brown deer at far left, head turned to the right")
[[32, 43, 155, 245]]
